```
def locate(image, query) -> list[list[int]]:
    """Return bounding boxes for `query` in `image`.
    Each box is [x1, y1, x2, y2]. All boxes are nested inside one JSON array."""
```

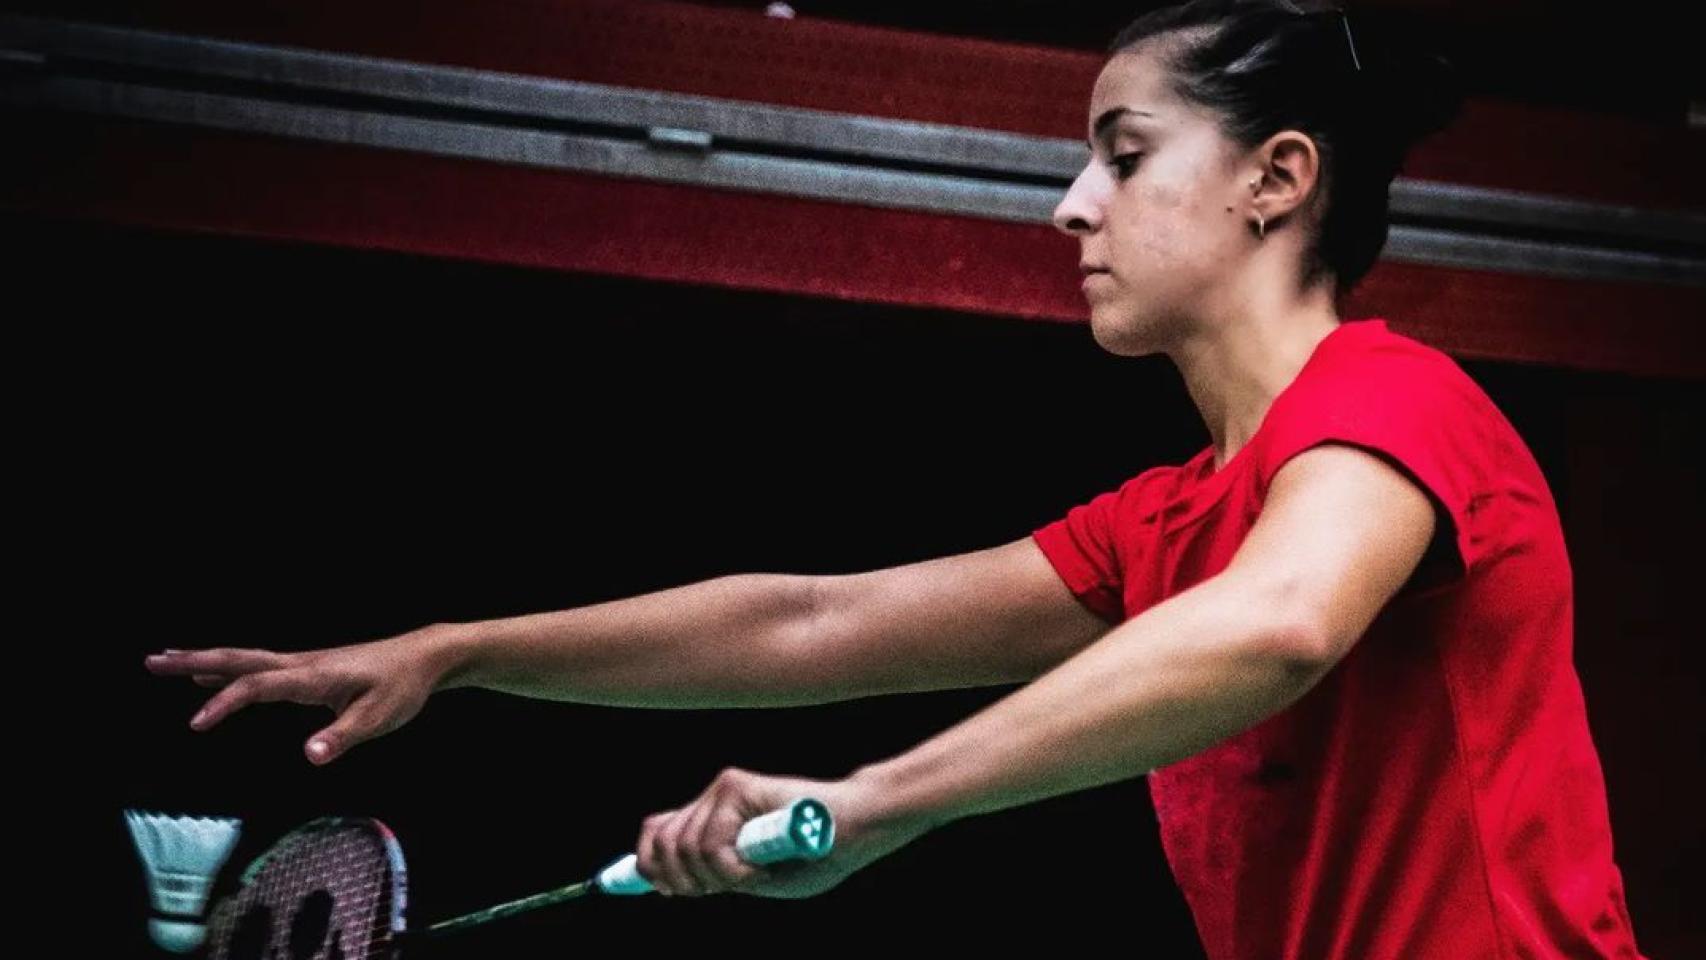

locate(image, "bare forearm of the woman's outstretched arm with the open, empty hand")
[[442, 573, 822, 708]]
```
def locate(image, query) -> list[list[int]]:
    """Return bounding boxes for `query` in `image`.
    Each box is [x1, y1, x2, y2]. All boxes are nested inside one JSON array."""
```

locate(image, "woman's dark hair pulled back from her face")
[[1109, 0, 1464, 293]]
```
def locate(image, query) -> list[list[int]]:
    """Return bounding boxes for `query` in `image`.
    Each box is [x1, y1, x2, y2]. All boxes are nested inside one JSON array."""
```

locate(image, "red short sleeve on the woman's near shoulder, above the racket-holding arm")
[[1256, 348, 1498, 588]]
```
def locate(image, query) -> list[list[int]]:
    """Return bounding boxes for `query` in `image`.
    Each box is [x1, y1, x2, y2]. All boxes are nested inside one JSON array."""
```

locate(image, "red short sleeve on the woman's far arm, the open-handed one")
[[1030, 467, 1165, 624]]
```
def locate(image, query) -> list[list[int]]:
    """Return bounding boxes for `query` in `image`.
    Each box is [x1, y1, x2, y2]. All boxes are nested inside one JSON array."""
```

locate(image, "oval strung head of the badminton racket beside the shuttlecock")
[[206, 817, 408, 960]]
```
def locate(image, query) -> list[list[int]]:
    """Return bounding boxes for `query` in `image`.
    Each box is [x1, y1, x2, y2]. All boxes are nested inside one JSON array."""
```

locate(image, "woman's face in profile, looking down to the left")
[[1054, 46, 1254, 356]]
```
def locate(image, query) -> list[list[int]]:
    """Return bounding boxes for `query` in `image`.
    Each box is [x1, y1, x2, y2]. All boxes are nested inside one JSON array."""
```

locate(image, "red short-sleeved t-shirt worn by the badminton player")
[[1034, 321, 1638, 960]]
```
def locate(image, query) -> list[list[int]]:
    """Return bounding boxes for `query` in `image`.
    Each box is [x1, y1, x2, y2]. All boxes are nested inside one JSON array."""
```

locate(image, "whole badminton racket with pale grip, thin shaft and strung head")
[[208, 798, 834, 960]]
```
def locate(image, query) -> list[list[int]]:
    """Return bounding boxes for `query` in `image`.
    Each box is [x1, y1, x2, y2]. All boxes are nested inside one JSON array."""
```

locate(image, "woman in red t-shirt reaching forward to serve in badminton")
[[148, 0, 1636, 960]]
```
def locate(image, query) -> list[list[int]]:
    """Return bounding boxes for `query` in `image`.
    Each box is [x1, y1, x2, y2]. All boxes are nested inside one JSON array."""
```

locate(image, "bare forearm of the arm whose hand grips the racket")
[[853, 569, 1322, 824]]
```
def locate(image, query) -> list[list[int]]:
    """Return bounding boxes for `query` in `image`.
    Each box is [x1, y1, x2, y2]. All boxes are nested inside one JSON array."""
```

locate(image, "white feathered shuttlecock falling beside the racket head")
[[125, 810, 242, 953]]
